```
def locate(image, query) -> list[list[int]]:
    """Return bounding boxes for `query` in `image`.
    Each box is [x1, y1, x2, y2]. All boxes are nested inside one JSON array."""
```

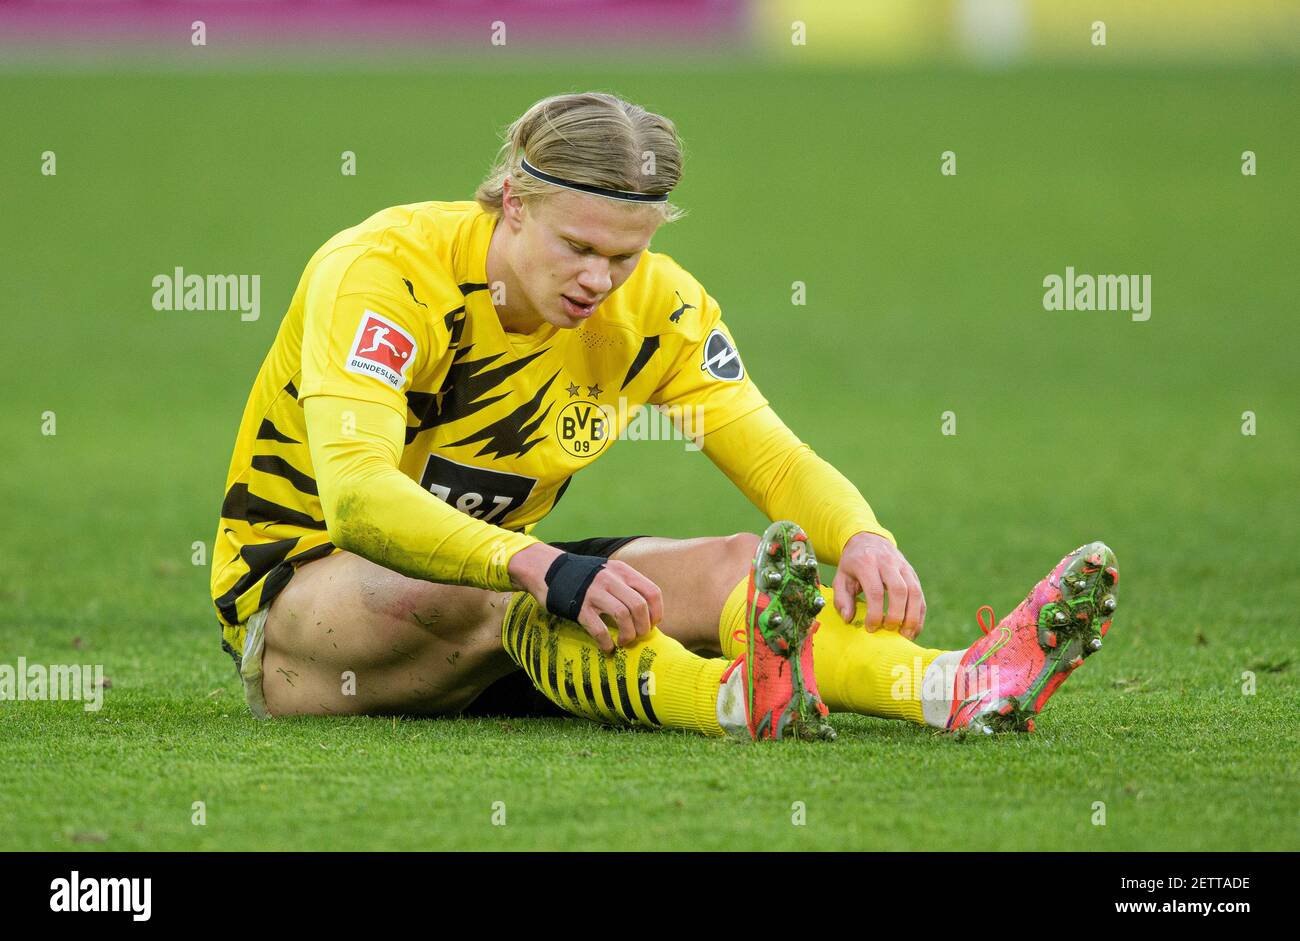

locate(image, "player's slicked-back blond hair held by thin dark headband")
[[475, 91, 686, 222]]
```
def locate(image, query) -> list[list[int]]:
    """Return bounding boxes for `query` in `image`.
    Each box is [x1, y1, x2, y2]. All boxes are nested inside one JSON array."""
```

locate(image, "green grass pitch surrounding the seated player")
[[0, 68, 1300, 850]]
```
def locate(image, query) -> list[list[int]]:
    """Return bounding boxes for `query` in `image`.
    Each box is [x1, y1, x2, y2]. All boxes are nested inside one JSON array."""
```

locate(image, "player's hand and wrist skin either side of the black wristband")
[[508, 542, 663, 654]]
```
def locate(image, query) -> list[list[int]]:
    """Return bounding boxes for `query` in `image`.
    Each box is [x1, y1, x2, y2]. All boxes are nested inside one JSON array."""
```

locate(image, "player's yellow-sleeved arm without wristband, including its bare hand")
[[703, 404, 926, 637]]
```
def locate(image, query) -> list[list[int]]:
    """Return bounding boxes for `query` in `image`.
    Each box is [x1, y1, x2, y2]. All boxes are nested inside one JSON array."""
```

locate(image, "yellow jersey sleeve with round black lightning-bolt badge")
[[650, 283, 767, 434]]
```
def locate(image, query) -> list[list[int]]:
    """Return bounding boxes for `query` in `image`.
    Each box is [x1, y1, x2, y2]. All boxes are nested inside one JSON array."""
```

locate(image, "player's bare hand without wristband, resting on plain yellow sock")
[[831, 533, 926, 639]]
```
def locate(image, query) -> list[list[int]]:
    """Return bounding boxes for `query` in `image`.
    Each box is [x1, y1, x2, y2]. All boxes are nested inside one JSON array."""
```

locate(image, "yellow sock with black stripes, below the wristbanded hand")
[[501, 591, 728, 736]]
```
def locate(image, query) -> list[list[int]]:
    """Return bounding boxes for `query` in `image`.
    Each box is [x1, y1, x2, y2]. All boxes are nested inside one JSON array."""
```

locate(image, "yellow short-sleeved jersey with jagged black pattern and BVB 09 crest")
[[212, 201, 764, 656]]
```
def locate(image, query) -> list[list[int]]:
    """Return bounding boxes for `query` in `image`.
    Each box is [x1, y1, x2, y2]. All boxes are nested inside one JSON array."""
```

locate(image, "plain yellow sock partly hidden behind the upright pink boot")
[[718, 576, 944, 724]]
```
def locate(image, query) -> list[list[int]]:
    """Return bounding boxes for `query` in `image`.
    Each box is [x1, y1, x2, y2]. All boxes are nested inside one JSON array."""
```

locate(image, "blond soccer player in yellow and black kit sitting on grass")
[[212, 94, 1118, 738]]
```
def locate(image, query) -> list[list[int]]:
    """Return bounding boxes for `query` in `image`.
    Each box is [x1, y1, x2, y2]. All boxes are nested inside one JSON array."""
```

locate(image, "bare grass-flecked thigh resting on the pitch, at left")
[[263, 552, 512, 715]]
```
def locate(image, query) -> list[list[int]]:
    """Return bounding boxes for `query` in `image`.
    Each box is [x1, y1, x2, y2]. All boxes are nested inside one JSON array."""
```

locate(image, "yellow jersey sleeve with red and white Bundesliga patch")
[[298, 247, 446, 417]]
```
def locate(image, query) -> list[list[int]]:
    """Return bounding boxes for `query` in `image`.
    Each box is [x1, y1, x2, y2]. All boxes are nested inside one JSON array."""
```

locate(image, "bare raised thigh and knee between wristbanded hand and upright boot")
[[611, 533, 758, 651]]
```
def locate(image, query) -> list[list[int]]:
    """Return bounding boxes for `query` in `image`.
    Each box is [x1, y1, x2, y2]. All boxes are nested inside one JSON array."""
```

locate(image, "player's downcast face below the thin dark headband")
[[516, 191, 662, 328]]
